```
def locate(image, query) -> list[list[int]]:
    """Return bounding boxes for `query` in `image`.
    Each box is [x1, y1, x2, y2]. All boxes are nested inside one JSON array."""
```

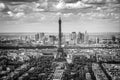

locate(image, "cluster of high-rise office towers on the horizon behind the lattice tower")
[[35, 32, 89, 45]]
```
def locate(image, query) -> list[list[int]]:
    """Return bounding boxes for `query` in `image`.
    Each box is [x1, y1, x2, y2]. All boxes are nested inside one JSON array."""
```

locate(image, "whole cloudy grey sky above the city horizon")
[[0, 0, 120, 33]]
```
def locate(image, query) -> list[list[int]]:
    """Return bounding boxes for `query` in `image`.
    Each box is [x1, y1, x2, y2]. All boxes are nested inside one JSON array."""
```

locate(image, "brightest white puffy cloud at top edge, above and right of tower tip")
[[54, 0, 91, 9]]
